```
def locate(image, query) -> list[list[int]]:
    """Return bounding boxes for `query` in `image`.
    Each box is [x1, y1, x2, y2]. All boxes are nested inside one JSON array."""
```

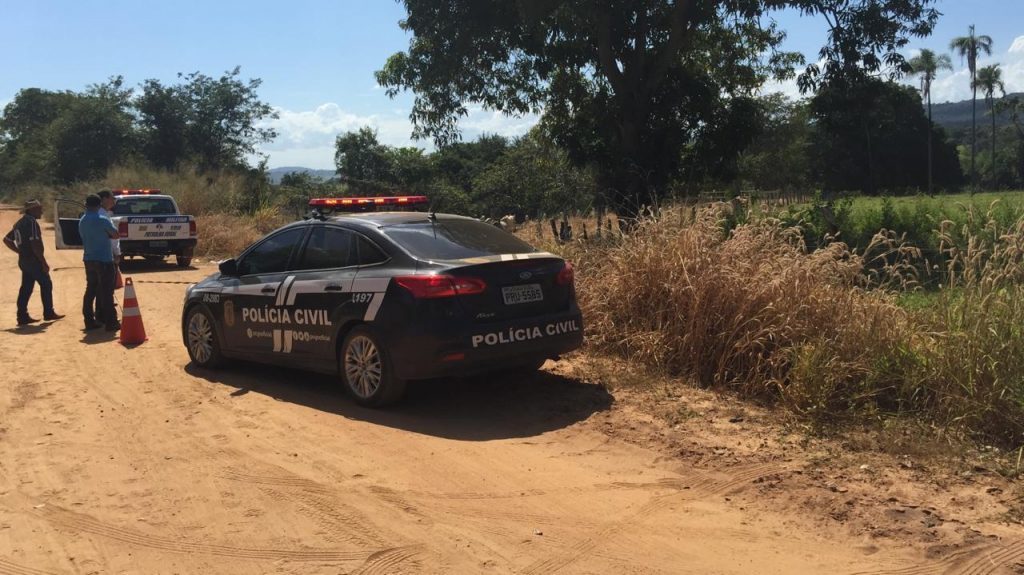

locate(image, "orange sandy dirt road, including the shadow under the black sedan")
[[0, 206, 1024, 575]]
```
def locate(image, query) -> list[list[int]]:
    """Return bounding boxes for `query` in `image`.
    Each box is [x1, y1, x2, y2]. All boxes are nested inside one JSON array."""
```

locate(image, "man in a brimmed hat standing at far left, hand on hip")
[[3, 200, 63, 325]]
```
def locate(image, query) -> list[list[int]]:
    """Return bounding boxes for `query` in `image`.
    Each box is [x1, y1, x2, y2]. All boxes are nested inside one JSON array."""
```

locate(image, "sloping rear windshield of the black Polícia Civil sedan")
[[383, 219, 537, 260]]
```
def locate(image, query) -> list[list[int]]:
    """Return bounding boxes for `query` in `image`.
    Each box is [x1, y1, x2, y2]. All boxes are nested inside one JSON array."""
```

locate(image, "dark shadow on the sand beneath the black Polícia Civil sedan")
[[185, 362, 613, 441]]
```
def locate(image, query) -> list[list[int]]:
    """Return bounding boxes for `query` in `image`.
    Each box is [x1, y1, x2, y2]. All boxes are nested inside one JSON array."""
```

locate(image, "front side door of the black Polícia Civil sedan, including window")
[[221, 226, 308, 354]]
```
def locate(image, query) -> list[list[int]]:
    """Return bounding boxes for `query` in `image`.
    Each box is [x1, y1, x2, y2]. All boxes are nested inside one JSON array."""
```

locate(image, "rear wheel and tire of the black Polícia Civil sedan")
[[338, 325, 406, 407]]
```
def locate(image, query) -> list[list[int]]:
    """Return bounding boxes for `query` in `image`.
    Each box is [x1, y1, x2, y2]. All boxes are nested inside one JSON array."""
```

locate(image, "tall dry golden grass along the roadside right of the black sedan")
[[562, 207, 1024, 445]]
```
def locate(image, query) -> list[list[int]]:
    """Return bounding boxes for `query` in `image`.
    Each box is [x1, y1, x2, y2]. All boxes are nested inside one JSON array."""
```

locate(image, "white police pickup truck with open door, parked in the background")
[[53, 189, 197, 267]]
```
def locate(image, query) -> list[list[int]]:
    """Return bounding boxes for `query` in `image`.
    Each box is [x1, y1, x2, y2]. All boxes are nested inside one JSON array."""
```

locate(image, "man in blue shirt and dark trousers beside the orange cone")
[[78, 195, 121, 331]]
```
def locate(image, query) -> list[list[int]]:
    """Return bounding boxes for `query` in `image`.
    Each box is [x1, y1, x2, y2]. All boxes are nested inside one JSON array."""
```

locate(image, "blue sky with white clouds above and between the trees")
[[0, 0, 1024, 168]]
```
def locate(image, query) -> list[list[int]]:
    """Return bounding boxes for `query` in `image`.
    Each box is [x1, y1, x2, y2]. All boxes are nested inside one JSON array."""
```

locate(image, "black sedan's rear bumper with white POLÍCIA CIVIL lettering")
[[389, 306, 584, 380]]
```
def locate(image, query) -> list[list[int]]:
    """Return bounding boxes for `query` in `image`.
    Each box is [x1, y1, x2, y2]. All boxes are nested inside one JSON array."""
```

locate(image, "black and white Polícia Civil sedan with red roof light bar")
[[181, 196, 583, 406]]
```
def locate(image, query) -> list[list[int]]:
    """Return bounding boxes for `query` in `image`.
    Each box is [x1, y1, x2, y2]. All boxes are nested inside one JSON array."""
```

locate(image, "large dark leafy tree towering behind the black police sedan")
[[377, 0, 937, 215]]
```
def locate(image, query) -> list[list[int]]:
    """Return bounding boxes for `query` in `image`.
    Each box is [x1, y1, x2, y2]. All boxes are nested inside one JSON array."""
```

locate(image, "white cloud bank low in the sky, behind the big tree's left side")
[[260, 102, 539, 169]]
